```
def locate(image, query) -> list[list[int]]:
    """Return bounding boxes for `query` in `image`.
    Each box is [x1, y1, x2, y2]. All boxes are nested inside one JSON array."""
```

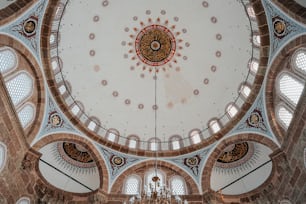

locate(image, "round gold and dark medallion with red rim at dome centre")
[[135, 24, 176, 66]]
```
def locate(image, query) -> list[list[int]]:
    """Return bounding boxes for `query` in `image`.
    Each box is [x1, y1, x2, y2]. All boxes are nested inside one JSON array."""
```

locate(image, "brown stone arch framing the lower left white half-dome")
[[32, 133, 109, 192]]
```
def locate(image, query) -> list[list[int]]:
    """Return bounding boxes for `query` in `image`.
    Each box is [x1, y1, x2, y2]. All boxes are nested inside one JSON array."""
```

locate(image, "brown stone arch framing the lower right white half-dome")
[[201, 133, 278, 192]]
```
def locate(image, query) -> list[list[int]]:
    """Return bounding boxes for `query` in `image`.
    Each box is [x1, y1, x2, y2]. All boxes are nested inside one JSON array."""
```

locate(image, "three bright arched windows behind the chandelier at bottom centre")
[[122, 169, 188, 195]]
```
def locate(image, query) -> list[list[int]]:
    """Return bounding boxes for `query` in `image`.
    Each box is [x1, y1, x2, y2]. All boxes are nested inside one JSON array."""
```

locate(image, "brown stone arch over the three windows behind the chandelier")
[[110, 160, 200, 194]]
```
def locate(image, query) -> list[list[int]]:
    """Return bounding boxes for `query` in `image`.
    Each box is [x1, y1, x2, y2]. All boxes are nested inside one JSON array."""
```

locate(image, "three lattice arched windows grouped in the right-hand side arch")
[[275, 48, 306, 129]]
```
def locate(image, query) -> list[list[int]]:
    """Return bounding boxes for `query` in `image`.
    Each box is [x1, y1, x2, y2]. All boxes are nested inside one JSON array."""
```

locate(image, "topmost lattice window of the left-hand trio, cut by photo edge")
[[0, 47, 18, 74]]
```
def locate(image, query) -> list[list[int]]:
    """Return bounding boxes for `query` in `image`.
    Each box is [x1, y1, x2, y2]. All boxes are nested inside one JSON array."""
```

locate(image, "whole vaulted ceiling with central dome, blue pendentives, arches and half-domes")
[[0, 0, 306, 202]]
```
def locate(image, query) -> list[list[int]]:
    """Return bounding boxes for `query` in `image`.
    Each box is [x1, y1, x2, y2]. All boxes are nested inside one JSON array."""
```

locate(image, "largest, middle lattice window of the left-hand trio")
[[5, 72, 33, 106]]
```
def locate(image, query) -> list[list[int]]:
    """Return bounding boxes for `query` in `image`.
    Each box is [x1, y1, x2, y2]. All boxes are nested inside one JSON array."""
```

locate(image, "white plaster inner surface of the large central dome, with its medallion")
[[58, 0, 253, 143]]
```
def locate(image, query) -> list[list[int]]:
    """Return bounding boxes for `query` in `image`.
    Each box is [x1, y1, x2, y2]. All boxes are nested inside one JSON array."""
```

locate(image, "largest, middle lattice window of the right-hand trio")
[[278, 73, 304, 106]]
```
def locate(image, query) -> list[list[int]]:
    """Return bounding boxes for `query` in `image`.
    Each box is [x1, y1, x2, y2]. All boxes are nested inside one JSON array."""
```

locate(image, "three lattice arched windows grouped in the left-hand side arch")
[[0, 47, 35, 128]]
